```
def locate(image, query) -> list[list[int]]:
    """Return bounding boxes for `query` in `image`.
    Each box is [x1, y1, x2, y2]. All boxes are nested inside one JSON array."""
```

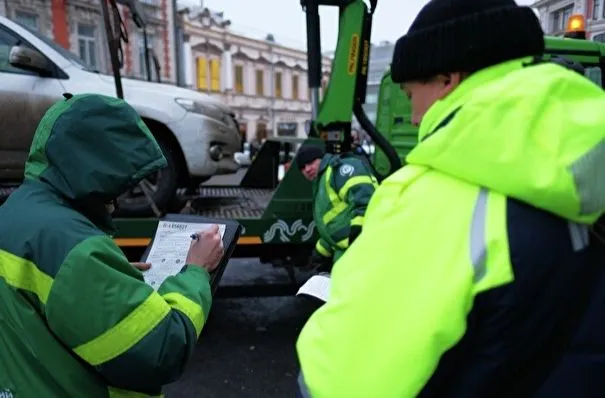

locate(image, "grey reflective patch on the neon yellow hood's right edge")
[[569, 140, 605, 215]]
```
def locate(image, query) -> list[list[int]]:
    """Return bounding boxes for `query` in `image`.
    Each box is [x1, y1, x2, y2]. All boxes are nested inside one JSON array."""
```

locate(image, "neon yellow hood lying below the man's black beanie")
[[406, 59, 605, 223]]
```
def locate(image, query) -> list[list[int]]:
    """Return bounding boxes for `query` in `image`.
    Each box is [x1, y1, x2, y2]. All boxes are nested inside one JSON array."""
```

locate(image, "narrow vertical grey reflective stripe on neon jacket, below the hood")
[[470, 188, 489, 283]]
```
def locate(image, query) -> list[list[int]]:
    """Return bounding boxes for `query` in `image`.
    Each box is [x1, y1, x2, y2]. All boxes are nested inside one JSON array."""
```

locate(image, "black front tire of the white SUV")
[[114, 140, 178, 217]]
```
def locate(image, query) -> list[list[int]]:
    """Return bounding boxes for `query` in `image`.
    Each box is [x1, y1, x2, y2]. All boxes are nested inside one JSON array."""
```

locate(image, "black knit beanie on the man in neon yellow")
[[391, 0, 544, 83]]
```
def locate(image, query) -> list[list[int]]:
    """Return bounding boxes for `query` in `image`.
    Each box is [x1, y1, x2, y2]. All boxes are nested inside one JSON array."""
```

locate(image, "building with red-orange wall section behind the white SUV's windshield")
[[0, 0, 176, 83]]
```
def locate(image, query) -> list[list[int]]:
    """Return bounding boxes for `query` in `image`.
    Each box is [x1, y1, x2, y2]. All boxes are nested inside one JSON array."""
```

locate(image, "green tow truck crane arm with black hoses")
[[300, 0, 401, 179]]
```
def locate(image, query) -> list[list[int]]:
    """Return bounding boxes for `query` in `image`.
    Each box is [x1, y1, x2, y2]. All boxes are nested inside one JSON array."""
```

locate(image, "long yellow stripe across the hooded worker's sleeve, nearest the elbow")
[[73, 292, 170, 366]]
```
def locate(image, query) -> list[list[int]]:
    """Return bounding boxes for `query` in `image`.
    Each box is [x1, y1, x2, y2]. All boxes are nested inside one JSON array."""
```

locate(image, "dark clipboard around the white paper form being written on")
[[141, 214, 242, 296]]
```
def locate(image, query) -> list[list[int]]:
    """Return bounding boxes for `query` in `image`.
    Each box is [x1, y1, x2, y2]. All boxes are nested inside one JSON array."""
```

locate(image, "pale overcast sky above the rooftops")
[[178, 0, 533, 51]]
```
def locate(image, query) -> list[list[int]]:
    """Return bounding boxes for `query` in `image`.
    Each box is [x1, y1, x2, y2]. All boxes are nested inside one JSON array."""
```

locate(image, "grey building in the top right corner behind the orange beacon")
[[532, 0, 605, 41]]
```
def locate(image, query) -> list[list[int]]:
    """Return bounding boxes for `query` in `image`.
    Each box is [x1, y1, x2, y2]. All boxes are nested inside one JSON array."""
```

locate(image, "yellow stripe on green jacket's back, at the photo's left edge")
[[0, 250, 53, 304]]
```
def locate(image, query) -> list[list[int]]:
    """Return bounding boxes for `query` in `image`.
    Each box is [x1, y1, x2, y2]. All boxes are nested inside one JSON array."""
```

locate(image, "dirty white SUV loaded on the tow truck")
[[0, 16, 241, 216]]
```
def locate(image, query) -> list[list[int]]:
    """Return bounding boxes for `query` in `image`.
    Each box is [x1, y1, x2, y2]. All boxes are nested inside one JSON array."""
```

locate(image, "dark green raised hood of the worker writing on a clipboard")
[[25, 94, 166, 203]]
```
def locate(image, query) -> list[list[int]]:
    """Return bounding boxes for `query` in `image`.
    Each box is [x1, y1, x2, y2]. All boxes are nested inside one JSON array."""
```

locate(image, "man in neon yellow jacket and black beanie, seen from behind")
[[297, 0, 605, 398]]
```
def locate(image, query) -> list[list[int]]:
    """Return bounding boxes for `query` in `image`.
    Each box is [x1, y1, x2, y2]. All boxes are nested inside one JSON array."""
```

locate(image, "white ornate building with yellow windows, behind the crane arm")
[[179, 7, 331, 142]]
